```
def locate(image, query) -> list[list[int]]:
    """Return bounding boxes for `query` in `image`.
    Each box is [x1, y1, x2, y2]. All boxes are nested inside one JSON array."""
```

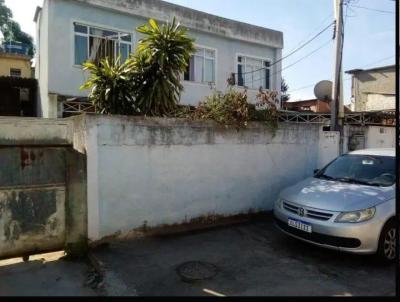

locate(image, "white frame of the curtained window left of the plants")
[[71, 20, 137, 69]]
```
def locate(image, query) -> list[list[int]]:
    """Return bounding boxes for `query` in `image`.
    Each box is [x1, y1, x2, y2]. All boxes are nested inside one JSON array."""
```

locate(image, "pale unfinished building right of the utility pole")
[[346, 65, 396, 112]]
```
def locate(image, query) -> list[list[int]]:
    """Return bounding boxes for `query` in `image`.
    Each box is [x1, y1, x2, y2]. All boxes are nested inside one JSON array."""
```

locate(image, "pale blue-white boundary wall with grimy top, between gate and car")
[[74, 116, 320, 241]]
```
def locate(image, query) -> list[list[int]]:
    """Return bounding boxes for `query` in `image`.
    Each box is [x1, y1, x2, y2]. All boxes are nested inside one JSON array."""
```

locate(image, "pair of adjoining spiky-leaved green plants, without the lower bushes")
[[81, 18, 195, 116]]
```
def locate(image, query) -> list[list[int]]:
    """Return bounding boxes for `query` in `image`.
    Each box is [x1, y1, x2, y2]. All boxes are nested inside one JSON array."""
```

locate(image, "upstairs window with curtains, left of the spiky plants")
[[74, 23, 133, 65]]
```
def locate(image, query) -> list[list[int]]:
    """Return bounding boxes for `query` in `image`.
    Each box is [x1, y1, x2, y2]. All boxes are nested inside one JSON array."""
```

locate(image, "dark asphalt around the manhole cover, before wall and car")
[[94, 217, 395, 296]]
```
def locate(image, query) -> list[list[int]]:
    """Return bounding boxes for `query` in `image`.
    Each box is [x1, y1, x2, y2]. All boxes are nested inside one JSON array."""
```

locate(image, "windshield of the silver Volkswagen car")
[[315, 154, 396, 187]]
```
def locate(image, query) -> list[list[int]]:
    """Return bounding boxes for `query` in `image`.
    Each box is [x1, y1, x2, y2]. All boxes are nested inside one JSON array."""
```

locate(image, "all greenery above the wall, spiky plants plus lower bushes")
[[81, 18, 279, 132]]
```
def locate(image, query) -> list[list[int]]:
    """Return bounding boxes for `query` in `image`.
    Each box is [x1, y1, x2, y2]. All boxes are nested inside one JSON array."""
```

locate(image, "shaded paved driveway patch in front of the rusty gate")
[[0, 253, 96, 296]]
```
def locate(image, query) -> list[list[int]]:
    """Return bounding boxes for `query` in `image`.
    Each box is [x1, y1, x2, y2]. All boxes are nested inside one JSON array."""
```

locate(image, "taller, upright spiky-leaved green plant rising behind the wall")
[[128, 18, 195, 116]]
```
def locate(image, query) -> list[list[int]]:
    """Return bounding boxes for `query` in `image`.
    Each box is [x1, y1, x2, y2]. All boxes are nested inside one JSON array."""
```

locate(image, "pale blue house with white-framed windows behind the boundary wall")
[[34, 0, 283, 118]]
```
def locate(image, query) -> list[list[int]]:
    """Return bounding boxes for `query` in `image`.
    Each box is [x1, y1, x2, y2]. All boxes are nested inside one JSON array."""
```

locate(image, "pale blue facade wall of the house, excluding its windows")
[[37, 0, 283, 118]]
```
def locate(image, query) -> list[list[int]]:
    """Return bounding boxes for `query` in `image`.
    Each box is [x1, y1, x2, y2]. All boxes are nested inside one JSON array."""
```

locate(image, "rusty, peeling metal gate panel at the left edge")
[[0, 146, 67, 258]]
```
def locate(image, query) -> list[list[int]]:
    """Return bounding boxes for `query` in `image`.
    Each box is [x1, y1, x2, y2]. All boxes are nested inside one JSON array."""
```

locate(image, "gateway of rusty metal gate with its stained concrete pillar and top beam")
[[0, 118, 87, 258]]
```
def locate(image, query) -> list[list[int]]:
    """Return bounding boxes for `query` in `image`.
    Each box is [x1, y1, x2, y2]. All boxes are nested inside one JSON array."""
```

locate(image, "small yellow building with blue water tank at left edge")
[[0, 42, 32, 78]]
